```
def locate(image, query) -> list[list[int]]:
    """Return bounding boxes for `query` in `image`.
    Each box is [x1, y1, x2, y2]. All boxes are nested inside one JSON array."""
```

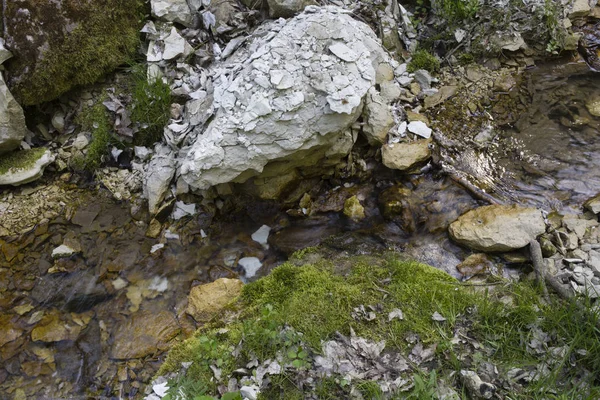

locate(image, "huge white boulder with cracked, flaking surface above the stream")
[[179, 6, 391, 189]]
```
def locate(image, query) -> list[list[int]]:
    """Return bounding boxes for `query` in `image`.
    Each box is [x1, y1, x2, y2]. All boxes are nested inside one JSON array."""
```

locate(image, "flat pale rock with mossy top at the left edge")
[[0, 147, 54, 186]]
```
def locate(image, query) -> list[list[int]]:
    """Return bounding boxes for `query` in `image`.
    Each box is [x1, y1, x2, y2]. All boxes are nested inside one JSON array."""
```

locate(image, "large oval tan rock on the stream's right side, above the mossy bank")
[[448, 205, 546, 252]]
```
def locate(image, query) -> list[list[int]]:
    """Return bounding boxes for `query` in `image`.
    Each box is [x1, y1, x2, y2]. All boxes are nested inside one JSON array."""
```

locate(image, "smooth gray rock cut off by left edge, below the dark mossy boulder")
[[0, 73, 27, 154]]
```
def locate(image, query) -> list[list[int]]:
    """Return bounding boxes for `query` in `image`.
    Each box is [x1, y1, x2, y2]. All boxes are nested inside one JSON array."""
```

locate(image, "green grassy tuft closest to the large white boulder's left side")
[[131, 64, 173, 146]]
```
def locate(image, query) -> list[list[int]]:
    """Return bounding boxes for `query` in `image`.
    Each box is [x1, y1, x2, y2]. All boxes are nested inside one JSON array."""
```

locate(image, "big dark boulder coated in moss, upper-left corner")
[[4, 0, 143, 105]]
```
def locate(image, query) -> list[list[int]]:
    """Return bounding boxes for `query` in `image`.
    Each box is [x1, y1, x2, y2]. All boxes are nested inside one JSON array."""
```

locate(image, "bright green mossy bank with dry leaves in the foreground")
[[159, 251, 600, 399]]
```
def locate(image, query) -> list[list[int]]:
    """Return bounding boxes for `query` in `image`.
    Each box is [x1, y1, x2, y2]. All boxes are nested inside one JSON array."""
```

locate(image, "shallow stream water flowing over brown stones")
[[0, 59, 600, 399]]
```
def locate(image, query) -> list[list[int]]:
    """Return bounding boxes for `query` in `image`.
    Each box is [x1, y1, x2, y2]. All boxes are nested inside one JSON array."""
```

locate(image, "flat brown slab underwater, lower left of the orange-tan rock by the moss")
[[110, 311, 180, 360]]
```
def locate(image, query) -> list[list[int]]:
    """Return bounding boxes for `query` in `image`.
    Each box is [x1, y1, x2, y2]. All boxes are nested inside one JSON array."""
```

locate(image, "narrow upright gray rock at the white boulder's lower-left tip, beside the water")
[[144, 145, 175, 214]]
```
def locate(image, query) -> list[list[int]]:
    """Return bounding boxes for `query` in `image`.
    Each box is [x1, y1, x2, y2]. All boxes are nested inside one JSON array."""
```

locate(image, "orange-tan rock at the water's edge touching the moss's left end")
[[186, 278, 244, 322]]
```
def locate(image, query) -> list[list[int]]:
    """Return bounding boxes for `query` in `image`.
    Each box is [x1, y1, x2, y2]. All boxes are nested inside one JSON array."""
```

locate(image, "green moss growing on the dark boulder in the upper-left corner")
[[13, 0, 143, 105]]
